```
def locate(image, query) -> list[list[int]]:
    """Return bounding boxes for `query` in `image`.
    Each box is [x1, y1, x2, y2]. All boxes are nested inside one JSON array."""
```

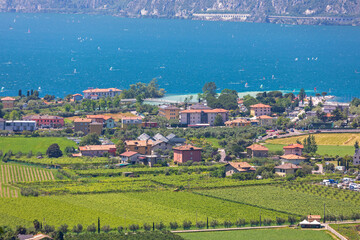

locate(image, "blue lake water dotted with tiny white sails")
[[0, 13, 360, 100]]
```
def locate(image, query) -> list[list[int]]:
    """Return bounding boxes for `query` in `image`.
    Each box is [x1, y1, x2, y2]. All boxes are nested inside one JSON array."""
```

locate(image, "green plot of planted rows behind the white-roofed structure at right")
[[197, 185, 360, 216]]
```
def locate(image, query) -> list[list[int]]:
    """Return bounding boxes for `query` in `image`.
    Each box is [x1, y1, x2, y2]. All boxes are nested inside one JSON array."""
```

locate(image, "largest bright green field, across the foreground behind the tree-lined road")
[[0, 191, 287, 227]]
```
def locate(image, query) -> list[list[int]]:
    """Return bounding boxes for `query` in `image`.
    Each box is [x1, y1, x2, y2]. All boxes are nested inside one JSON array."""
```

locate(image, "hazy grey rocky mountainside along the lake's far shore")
[[0, 0, 360, 24]]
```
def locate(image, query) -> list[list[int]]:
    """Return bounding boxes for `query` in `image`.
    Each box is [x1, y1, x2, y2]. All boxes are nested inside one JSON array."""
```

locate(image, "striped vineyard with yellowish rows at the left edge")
[[0, 164, 54, 198]]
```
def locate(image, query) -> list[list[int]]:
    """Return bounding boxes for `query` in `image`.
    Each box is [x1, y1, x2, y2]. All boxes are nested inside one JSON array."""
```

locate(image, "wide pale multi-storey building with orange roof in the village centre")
[[180, 108, 229, 126]]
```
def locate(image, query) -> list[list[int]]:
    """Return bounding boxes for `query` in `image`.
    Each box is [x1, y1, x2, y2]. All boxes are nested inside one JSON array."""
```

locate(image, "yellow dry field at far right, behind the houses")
[[266, 133, 360, 146]]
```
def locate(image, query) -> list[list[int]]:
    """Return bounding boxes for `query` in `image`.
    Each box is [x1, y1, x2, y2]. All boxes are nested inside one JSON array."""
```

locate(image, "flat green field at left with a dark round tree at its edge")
[[0, 136, 76, 154]]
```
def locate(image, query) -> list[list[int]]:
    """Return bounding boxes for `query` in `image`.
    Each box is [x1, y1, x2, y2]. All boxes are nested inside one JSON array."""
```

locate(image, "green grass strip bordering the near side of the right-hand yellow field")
[[265, 143, 354, 157]]
